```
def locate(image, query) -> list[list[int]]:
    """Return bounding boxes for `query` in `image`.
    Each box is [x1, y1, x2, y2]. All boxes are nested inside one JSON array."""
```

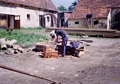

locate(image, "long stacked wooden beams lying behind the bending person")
[[45, 28, 120, 37]]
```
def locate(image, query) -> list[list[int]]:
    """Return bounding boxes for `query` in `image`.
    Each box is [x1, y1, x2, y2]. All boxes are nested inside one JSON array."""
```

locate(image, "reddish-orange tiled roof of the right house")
[[69, 0, 120, 19]]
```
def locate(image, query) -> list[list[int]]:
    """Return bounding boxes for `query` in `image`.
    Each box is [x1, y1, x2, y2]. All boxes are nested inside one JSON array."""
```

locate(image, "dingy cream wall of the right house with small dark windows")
[[68, 19, 107, 29]]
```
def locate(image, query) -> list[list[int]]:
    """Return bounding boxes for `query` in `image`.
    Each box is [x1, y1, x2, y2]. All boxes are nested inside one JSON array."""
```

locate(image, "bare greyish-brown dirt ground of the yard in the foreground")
[[0, 38, 120, 84]]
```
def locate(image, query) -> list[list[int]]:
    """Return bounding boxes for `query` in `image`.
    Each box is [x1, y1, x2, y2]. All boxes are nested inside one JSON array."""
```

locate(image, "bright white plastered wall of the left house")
[[0, 4, 57, 27]]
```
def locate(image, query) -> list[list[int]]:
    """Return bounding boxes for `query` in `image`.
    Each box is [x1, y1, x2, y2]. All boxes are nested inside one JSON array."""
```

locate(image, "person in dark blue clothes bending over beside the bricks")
[[50, 30, 68, 57]]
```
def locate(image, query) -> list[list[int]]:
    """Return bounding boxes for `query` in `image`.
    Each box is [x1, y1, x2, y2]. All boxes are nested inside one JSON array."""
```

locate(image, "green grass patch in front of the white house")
[[0, 28, 48, 46]]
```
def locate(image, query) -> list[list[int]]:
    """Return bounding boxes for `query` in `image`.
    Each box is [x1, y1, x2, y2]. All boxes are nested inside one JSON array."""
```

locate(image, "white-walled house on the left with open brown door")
[[0, 0, 57, 28]]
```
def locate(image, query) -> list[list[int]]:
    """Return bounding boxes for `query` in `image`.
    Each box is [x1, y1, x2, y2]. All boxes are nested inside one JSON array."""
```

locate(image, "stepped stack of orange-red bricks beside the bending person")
[[44, 46, 58, 59]]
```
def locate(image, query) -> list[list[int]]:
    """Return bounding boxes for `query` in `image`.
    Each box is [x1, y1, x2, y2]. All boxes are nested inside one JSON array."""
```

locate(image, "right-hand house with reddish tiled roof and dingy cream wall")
[[68, 0, 120, 30]]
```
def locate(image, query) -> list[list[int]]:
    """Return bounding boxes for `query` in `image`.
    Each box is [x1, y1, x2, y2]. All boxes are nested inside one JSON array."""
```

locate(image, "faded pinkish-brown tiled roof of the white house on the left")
[[0, 0, 57, 11]]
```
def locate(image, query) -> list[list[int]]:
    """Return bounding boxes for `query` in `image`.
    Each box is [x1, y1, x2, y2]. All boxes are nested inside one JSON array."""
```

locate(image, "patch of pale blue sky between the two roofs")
[[52, 0, 75, 8]]
